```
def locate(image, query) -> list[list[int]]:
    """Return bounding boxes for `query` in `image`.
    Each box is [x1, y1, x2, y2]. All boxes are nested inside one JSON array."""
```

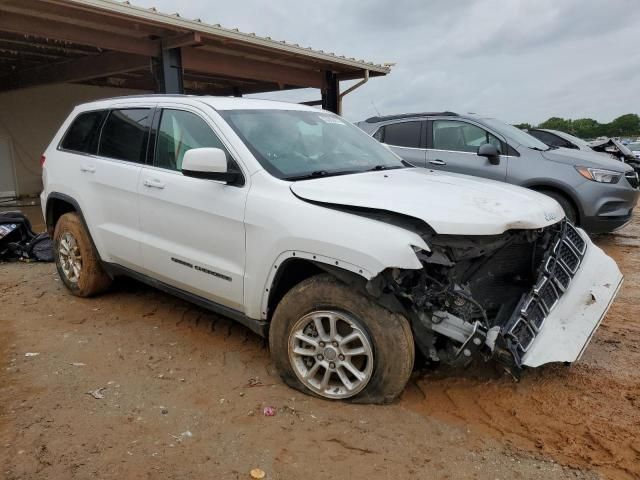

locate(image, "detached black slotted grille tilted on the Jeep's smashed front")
[[505, 221, 587, 364]]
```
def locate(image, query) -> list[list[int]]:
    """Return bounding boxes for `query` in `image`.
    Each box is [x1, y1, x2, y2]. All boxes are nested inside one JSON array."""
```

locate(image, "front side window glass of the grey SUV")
[[432, 120, 502, 153]]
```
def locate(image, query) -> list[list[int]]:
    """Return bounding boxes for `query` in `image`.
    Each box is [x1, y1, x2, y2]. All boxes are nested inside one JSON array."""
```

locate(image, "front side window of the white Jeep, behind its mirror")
[[154, 109, 230, 171]]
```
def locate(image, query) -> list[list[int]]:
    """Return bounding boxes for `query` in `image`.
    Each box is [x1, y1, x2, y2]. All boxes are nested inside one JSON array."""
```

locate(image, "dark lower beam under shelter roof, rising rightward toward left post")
[[0, 52, 151, 91]]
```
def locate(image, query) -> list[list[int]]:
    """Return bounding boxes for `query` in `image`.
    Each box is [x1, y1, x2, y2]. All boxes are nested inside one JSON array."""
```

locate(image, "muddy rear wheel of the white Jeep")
[[53, 212, 111, 297]]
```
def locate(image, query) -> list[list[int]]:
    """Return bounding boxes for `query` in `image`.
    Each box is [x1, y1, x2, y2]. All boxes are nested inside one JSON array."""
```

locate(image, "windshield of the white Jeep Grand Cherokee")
[[219, 110, 405, 180]]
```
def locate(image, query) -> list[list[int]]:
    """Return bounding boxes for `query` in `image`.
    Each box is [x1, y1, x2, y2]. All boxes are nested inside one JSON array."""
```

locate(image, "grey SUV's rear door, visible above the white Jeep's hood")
[[373, 120, 427, 167]]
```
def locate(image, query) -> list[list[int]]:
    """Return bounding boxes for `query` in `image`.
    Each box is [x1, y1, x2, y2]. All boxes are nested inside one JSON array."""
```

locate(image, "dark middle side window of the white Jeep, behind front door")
[[98, 108, 151, 163]]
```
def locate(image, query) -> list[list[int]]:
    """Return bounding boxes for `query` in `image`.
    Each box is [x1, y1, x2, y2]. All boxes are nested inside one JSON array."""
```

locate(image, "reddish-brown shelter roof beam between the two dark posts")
[[182, 48, 323, 88]]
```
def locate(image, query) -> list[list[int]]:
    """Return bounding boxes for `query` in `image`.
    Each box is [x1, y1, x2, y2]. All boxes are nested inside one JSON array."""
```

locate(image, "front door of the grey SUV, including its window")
[[427, 120, 508, 182]]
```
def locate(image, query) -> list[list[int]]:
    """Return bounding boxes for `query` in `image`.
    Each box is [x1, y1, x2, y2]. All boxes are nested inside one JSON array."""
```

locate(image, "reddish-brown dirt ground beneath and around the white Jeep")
[[0, 207, 640, 480]]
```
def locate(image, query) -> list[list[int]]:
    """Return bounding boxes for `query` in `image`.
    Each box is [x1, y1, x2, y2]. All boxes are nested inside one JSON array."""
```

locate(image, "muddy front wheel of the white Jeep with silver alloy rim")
[[269, 275, 415, 403]]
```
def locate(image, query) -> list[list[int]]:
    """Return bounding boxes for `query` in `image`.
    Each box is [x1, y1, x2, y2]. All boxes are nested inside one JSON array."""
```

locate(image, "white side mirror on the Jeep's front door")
[[182, 148, 244, 185]]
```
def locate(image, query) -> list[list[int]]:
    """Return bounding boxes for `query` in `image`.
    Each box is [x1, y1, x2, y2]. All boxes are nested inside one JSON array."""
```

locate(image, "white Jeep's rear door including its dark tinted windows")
[[60, 106, 153, 269]]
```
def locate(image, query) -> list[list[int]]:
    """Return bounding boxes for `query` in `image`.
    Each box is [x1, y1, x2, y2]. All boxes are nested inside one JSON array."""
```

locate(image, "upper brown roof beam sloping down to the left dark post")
[[0, 12, 160, 56]]
